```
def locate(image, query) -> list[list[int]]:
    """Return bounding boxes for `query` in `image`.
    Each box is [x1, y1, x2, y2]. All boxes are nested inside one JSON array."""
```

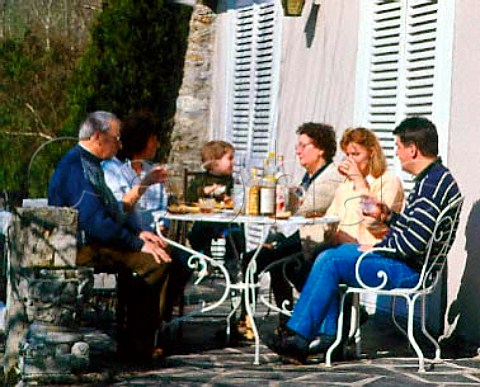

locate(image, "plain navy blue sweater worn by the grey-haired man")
[[48, 145, 144, 251]]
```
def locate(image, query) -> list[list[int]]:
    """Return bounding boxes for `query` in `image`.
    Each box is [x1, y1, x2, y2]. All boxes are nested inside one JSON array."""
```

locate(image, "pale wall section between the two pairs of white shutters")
[[278, 0, 358, 180]]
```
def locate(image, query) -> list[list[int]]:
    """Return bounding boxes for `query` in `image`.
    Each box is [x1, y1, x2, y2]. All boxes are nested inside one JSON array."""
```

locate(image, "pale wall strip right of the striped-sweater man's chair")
[[447, 0, 480, 343]]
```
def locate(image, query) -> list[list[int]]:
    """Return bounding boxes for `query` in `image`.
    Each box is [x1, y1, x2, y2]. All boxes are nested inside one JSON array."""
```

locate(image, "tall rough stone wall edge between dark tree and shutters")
[[169, 4, 215, 202]]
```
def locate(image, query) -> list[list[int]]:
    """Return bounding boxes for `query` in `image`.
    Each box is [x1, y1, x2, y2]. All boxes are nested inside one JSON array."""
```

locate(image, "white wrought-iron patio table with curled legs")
[[154, 210, 339, 364]]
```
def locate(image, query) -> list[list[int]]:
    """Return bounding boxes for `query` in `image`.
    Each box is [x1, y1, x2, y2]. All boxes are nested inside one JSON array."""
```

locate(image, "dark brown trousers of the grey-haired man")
[[77, 246, 170, 359]]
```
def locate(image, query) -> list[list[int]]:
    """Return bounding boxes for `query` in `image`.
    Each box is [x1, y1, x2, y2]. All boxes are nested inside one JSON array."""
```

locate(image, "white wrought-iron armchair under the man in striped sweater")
[[325, 197, 463, 372]]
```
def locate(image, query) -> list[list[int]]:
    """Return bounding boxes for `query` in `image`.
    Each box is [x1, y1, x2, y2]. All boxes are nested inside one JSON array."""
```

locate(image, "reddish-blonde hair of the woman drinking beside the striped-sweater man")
[[340, 127, 387, 178]]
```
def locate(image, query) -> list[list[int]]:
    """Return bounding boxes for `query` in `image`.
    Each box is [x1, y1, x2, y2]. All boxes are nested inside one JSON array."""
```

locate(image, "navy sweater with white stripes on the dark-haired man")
[[375, 159, 460, 269]]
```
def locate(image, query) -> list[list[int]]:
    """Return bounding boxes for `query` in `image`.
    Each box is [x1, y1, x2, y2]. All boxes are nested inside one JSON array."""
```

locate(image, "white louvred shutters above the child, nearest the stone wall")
[[226, 1, 280, 249]]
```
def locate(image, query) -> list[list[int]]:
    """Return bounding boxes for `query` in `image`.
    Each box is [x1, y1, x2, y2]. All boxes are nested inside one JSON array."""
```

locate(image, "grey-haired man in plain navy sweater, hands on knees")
[[48, 111, 171, 360]]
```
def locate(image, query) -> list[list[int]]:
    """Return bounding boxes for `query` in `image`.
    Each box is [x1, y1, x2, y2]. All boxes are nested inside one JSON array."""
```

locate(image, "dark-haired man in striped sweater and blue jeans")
[[269, 117, 460, 362]]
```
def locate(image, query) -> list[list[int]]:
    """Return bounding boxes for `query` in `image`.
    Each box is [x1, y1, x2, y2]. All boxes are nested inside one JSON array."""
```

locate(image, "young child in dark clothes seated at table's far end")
[[186, 140, 245, 283]]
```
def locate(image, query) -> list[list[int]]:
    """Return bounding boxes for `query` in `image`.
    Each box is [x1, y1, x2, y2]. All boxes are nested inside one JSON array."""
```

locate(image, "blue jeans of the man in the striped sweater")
[[287, 244, 419, 340]]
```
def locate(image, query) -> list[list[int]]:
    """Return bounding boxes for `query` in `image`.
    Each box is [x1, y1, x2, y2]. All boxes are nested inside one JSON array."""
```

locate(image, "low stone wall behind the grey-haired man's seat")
[[4, 207, 108, 385]]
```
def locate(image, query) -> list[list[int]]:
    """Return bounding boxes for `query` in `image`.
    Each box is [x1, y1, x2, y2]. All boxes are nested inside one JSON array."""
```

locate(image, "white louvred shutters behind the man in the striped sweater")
[[355, 0, 453, 190]]
